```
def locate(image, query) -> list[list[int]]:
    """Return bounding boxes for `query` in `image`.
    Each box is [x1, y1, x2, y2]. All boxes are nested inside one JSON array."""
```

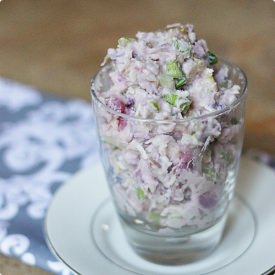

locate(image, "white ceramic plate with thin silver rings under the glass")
[[45, 158, 275, 275]]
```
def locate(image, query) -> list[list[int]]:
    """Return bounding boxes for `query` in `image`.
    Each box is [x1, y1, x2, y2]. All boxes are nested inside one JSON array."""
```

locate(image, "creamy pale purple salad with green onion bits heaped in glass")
[[93, 24, 245, 233]]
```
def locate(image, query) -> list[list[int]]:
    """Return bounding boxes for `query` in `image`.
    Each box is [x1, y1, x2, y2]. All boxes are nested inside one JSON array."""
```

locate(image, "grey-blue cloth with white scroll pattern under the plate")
[[0, 78, 275, 275]]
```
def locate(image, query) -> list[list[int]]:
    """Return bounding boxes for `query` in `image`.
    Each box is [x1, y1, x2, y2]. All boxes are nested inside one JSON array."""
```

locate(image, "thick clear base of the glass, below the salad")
[[121, 217, 226, 265]]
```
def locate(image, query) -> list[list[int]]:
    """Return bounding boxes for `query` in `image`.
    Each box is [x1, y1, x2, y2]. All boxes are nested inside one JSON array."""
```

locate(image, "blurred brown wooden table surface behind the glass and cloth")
[[0, 0, 275, 275]]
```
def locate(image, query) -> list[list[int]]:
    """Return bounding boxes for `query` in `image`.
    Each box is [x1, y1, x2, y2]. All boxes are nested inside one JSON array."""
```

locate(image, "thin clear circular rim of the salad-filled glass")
[[91, 59, 248, 123]]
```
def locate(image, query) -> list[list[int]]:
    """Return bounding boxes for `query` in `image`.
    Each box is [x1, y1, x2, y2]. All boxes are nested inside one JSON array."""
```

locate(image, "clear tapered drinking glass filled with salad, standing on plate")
[[91, 61, 247, 264]]
